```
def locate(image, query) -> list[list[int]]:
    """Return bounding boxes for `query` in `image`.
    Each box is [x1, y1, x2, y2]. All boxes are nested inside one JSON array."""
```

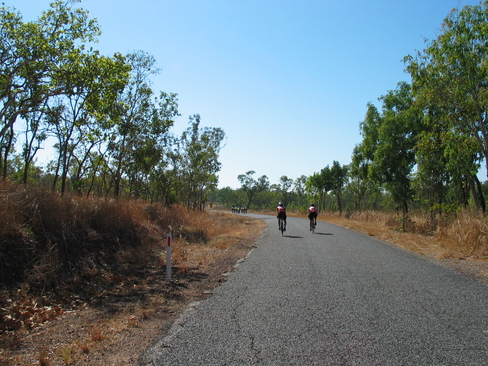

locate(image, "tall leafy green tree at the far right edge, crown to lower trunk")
[[405, 2, 488, 210]]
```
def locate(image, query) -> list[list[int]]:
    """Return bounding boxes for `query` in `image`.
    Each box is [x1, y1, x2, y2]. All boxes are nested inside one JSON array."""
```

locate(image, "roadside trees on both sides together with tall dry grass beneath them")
[[0, 1, 488, 364]]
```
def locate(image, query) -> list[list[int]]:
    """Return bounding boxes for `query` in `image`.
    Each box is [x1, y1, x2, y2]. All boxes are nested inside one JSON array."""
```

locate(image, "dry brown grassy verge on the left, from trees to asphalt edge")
[[0, 182, 265, 365]]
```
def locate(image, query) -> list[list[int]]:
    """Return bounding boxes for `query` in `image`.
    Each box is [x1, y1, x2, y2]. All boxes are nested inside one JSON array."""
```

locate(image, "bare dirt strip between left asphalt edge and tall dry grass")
[[0, 213, 266, 366]]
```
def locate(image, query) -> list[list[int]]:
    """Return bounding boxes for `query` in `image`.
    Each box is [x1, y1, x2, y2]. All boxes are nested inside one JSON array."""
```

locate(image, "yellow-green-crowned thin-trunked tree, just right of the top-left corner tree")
[[47, 51, 129, 193]]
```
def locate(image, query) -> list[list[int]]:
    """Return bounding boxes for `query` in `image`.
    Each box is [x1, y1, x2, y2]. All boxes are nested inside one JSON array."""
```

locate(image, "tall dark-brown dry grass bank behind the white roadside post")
[[0, 181, 172, 290]]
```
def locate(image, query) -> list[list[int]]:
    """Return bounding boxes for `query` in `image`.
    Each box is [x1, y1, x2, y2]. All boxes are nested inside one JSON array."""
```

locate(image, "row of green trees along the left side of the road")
[[0, 5, 225, 209]]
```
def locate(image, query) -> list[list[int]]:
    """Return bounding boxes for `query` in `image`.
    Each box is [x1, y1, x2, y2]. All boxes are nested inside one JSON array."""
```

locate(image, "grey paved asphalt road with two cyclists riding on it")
[[141, 215, 488, 366]]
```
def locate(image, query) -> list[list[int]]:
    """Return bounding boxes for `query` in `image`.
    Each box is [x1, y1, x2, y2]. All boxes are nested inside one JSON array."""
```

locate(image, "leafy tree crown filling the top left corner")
[[0, 0, 100, 162]]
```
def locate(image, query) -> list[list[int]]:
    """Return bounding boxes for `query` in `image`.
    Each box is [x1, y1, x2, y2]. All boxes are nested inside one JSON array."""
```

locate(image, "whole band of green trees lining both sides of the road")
[[0, 0, 488, 220]]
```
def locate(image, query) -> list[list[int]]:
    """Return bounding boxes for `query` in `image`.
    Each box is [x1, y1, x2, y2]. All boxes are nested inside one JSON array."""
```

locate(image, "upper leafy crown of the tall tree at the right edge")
[[404, 1, 488, 180]]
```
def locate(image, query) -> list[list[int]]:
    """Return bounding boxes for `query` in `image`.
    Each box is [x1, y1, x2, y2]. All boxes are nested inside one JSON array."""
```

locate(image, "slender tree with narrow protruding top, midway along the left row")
[[107, 51, 179, 197]]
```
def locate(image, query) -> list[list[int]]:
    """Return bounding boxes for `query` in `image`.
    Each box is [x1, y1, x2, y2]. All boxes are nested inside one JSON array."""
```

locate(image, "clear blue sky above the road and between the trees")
[[9, 0, 479, 188]]
